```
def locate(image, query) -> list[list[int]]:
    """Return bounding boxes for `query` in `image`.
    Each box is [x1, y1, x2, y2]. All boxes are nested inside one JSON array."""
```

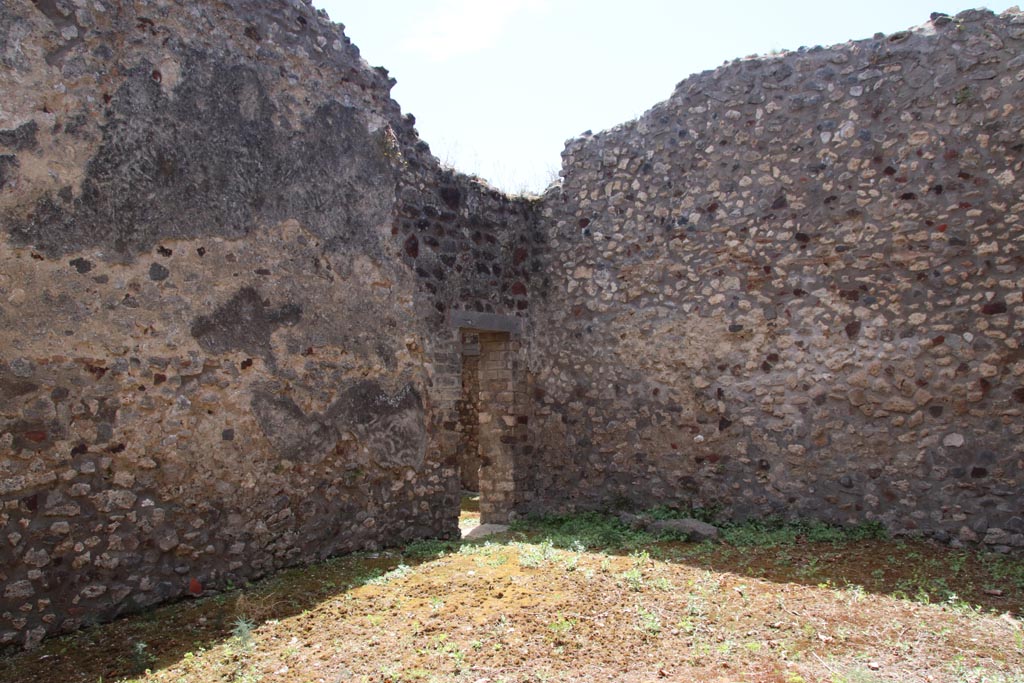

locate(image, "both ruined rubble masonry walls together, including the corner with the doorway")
[[0, 0, 1024, 645]]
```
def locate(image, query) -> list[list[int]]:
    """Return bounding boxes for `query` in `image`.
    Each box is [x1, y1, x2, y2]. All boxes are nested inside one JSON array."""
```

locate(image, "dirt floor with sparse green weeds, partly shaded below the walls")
[[0, 502, 1024, 683]]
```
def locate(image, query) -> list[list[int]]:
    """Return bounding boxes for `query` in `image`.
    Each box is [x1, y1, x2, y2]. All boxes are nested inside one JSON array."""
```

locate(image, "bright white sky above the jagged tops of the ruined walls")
[[313, 0, 1010, 191]]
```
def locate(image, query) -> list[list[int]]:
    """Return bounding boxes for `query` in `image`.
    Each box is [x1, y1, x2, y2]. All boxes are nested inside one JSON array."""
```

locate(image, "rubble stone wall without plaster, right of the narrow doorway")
[[529, 10, 1024, 547]]
